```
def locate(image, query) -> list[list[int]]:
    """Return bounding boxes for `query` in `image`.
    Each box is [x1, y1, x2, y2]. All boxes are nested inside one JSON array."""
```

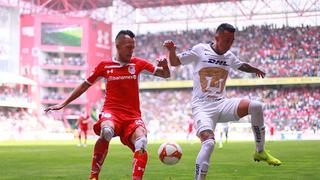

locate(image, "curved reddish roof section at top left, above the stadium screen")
[[23, 0, 113, 12]]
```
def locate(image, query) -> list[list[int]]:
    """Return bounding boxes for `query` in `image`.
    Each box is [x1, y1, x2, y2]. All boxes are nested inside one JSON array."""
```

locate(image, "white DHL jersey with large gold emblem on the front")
[[178, 43, 243, 105]]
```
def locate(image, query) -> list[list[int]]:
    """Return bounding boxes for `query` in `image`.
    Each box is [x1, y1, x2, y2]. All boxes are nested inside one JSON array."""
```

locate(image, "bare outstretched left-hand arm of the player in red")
[[44, 81, 91, 113]]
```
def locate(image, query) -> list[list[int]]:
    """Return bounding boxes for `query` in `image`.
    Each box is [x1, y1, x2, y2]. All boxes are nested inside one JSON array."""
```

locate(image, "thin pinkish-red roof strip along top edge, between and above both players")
[[122, 0, 235, 8]]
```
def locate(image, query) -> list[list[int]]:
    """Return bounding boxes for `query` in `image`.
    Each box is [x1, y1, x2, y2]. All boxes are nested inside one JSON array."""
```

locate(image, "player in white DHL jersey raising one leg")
[[163, 23, 281, 180]]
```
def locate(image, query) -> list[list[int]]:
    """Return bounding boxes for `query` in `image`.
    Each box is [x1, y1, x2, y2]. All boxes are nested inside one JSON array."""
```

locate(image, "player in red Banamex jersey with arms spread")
[[45, 30, 170, 180]]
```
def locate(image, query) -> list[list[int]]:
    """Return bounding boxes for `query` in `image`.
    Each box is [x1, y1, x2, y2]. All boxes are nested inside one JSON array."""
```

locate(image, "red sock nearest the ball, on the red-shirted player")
[[132, 150, 148, 180]]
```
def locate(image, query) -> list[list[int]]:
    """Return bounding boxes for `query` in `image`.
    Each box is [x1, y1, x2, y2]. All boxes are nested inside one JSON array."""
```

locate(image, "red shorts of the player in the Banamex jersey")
[[93, 111, 146, 152]]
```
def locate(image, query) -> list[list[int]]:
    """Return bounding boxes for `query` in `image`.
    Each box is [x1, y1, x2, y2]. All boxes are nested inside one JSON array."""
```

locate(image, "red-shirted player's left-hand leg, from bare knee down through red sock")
[[90, 120, 115, 180]]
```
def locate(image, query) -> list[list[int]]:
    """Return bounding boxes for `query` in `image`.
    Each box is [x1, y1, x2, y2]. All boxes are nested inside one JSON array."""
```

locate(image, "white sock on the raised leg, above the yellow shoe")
[[248, 101, 265, 152]]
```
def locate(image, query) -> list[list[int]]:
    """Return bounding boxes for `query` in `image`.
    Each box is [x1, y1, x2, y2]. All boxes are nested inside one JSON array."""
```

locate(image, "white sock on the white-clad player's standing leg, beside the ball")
[[195, 139, 215, 180]]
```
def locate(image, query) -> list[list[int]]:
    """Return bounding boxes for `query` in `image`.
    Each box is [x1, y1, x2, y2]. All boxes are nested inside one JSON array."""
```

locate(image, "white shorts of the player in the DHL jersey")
[[192, 98, 241, 136]]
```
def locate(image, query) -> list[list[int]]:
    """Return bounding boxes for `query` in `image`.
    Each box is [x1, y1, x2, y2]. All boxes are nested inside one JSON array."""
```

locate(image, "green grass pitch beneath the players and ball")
[[0, 141, 320, 180]]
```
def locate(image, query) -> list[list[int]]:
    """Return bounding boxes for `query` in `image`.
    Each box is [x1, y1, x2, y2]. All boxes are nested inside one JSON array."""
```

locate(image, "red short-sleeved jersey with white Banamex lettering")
[[86, 57, 156, 120]]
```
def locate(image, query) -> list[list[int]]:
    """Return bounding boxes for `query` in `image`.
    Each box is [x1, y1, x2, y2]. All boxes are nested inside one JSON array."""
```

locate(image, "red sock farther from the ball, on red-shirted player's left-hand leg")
[[90, 138, 109, 180]]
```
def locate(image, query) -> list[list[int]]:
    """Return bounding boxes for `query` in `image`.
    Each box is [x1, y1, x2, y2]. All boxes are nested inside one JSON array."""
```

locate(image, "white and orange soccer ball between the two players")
[[158, 142, 182, 165]]
